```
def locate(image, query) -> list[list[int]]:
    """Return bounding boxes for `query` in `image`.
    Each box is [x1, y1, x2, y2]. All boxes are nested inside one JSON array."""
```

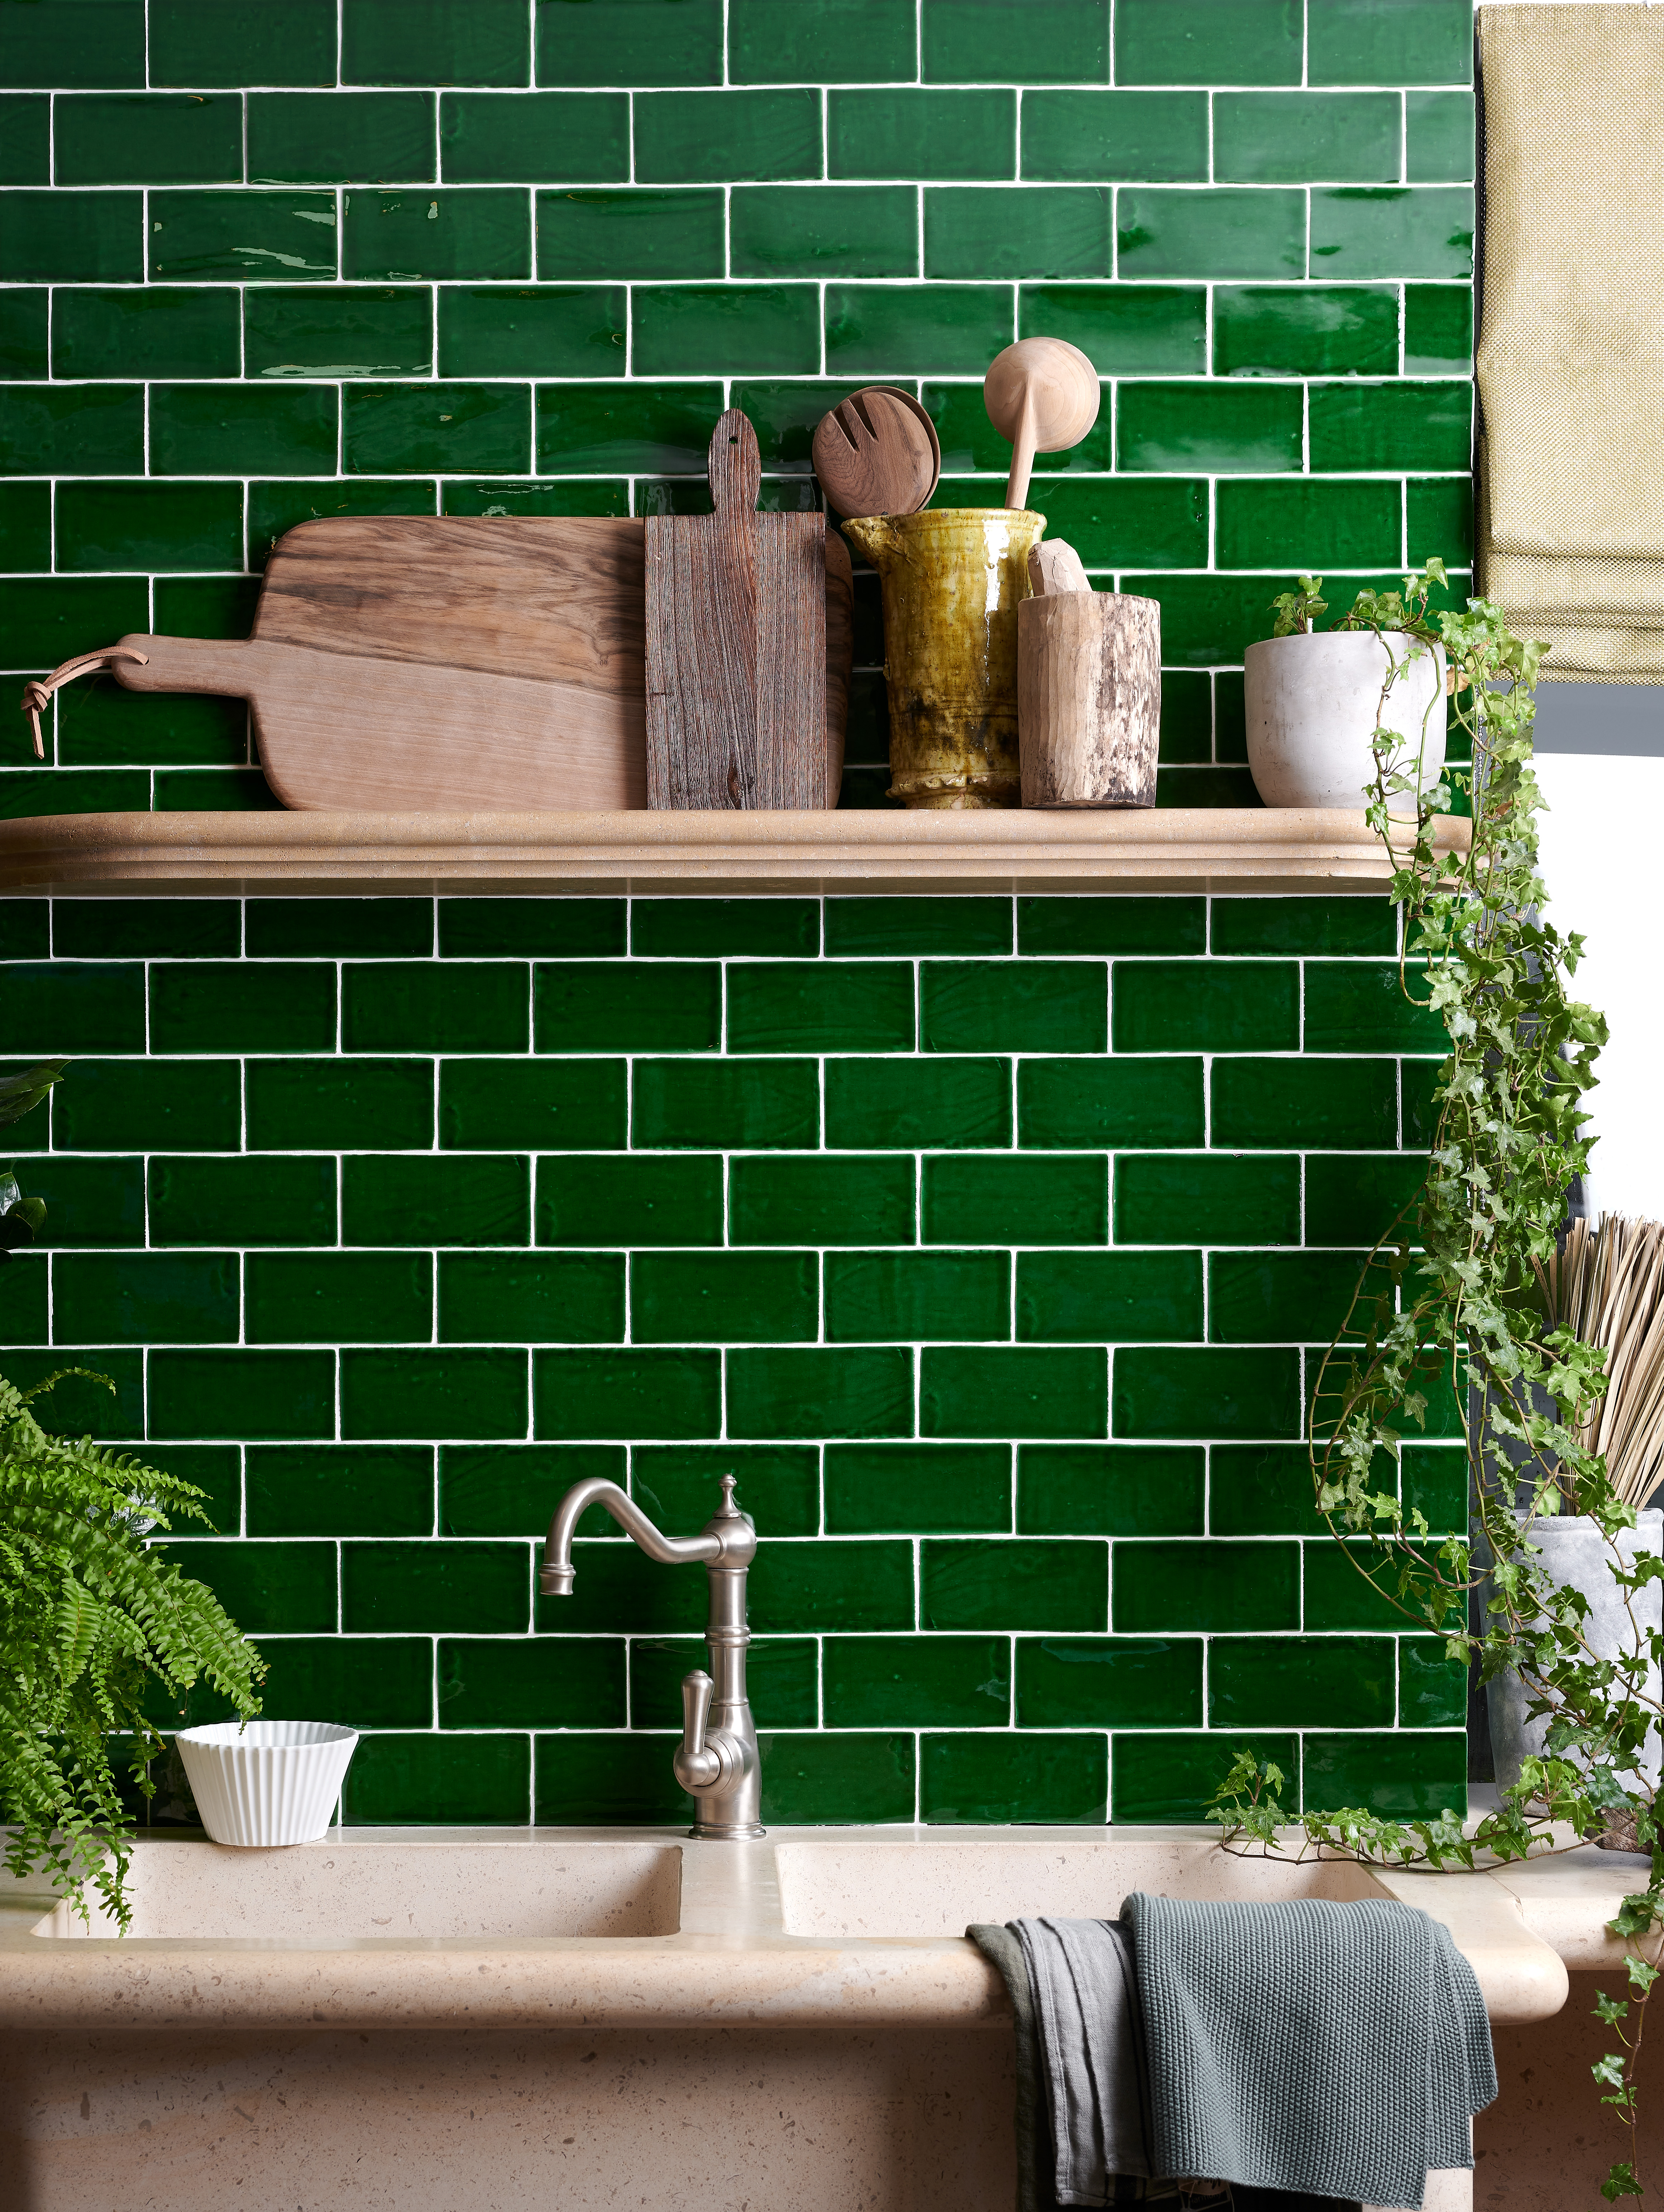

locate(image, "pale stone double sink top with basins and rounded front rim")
[[0, 1827, 1575, 2033]]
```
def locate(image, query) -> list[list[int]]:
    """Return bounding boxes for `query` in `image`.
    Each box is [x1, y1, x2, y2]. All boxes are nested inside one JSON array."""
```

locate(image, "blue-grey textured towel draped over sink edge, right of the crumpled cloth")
[[1122, 1891, 1496, 2212]]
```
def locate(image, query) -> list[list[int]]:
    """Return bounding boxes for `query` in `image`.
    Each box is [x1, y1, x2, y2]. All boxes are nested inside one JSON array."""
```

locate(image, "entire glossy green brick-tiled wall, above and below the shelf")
[[0, 0, 1474, 1823]]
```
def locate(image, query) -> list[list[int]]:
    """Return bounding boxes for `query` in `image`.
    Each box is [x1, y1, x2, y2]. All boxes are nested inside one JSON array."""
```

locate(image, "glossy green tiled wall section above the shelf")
[[0, 0, 1474, 814]]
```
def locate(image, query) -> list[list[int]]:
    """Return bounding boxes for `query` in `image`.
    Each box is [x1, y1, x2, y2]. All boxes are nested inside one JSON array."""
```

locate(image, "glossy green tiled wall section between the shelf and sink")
[[0, 896, 1465, 1820]]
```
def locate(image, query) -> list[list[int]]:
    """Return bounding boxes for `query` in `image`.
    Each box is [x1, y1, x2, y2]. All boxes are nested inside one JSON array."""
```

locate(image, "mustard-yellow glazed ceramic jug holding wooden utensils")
[[843, 507, 1047, 807]]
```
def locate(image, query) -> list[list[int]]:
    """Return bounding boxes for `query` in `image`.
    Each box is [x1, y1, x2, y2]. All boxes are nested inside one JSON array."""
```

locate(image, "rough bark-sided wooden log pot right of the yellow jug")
[[1018, 591, 1162, 807]]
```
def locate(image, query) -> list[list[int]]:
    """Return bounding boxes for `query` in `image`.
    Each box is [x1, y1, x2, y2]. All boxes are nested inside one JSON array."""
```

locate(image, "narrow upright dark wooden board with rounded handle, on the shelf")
[[646, 407, 836, 809]]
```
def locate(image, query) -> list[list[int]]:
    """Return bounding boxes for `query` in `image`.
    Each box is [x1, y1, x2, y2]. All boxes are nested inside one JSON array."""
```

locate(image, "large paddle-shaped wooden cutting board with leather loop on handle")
[[107, 515, 850, 814]]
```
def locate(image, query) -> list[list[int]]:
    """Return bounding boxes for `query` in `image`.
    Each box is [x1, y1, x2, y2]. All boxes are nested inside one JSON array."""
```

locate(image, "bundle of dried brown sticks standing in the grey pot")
[[1538, 1214, 1664, 1506]]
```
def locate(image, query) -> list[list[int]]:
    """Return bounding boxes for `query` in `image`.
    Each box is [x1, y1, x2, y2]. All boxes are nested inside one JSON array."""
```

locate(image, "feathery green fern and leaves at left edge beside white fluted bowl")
[[0, 1062, 266, 1931]]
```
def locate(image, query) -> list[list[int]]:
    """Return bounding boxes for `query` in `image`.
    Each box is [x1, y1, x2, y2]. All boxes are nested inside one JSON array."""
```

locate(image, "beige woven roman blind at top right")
[[1478, 4, 1664, 681]]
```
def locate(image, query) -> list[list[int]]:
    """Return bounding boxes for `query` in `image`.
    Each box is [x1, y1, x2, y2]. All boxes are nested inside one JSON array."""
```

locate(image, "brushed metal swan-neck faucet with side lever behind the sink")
[[538, 1475, 764, 1838]]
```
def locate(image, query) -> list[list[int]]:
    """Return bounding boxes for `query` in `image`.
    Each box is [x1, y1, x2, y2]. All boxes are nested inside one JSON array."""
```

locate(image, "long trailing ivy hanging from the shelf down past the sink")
[[1210, 560, 1664, 2201]]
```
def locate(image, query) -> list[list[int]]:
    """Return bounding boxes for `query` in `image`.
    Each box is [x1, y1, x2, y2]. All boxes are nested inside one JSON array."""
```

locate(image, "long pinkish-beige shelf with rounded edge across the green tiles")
[[0, 807, 1467, 896]]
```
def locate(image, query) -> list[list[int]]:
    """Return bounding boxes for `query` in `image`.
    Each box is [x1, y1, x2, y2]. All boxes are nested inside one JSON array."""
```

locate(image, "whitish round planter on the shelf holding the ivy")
[[1246, 630, 1445, 814]]
